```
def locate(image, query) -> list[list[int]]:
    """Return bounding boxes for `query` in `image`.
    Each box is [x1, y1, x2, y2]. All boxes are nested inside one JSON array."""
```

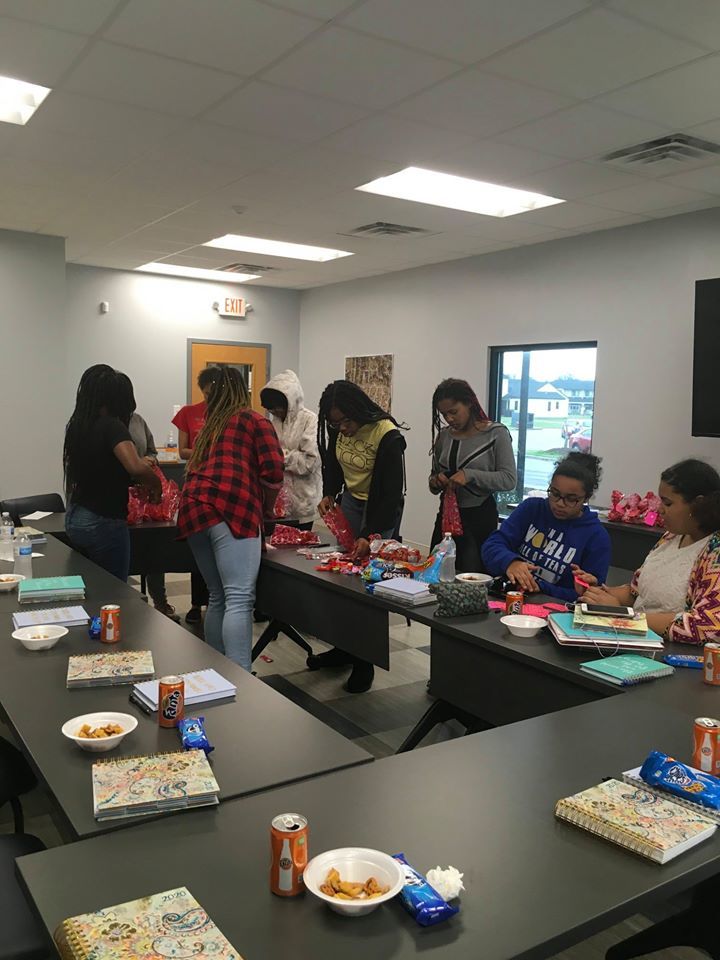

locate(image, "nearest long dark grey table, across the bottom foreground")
[[18, 681, 720, 960]]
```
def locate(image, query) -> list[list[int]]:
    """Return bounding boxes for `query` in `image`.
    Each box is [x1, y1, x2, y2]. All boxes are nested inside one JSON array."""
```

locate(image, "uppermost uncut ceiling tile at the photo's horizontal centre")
[[264, 27, 457, 108]]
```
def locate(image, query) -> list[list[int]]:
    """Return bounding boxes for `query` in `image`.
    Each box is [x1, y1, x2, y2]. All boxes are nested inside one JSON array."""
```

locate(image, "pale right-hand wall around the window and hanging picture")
[[300, 209, 720, 543]]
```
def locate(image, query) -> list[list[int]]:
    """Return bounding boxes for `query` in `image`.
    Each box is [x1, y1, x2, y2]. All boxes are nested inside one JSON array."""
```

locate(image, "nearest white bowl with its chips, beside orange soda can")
[[303, 847, 405, 917]]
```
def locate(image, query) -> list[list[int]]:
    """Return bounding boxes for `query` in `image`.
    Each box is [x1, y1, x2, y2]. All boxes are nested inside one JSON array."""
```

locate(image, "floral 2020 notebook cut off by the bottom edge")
[[53, 887, 242, 960]]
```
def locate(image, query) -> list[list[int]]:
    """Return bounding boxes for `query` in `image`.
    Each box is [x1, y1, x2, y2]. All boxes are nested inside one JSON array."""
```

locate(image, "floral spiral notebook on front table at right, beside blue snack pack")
[[555, 780, 717, 863]]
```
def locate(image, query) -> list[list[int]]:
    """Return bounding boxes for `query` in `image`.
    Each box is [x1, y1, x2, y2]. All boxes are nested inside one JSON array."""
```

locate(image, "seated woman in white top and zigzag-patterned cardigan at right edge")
[[577, 460, 720, 644]]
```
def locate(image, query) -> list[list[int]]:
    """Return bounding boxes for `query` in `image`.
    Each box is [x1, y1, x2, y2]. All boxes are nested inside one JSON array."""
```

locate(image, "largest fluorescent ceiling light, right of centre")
[[355, 167, 565, 217]]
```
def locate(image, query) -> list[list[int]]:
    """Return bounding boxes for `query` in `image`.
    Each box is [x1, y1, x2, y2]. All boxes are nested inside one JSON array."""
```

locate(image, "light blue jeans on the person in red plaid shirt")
[[188, 522, 261, 671]]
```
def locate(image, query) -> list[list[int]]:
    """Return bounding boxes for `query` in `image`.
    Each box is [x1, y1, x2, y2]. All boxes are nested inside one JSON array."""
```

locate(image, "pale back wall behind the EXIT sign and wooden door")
[[65, 264, 299, 445]]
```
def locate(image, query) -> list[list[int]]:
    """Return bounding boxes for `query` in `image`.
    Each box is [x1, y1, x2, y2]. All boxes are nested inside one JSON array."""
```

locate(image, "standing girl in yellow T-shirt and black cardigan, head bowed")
[[307, 380, 406, 693]]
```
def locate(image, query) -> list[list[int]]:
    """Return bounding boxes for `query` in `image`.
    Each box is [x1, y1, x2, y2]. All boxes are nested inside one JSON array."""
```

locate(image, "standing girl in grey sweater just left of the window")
[[429, 379, 517, 573]]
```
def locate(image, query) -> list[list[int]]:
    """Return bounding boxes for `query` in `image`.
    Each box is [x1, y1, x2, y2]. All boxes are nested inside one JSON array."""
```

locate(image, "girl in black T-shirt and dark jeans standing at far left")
[[63, 363, 161, 580]]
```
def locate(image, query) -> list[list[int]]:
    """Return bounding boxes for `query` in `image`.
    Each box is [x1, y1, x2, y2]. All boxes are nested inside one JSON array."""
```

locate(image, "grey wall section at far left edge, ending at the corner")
[[0, 230, 65, 499]]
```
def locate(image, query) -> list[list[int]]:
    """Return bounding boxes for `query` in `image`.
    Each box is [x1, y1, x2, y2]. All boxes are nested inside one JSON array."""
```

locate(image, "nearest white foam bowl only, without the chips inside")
[[303, 847, 405, 917]]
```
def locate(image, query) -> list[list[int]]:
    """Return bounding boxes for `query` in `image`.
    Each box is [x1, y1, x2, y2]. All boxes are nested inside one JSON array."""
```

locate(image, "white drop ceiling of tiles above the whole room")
[[0, 0, 720, 289]]
